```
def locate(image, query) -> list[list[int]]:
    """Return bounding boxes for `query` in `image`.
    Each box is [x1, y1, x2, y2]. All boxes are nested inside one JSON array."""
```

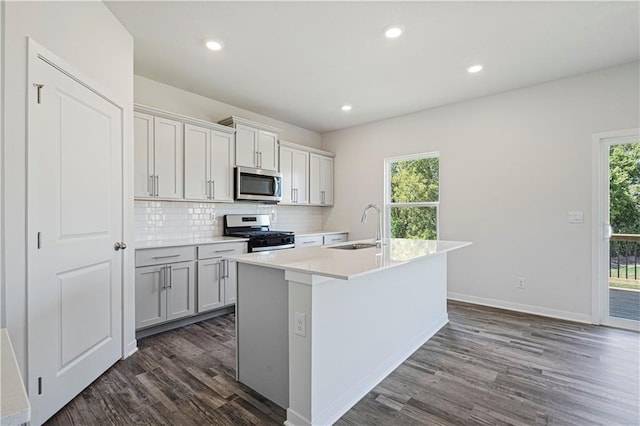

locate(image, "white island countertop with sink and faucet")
[[227, 239, 471, 280]]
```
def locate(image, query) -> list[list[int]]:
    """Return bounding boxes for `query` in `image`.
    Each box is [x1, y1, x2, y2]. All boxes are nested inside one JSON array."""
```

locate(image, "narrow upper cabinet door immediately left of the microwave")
[[211, 131, 234, 201]]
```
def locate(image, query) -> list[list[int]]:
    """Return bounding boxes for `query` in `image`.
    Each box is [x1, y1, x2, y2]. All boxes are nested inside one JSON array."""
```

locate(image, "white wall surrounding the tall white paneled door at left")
[[2, 2, 133, 374]]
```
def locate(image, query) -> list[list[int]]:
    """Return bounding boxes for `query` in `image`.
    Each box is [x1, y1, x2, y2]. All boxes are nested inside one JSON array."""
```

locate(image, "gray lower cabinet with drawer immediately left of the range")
[[197, 243, 247, 313]]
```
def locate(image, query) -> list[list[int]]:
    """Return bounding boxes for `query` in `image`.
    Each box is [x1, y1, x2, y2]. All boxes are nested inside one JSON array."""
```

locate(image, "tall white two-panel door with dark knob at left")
[[27, 50, 123, 424]]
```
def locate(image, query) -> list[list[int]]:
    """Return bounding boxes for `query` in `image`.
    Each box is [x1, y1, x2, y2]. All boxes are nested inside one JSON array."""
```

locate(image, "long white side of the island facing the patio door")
[[287, 254, 448, 425]]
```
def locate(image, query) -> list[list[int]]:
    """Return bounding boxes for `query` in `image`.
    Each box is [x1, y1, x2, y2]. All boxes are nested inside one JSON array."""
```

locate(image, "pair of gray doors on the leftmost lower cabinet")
[[135, 261, 196, 329]]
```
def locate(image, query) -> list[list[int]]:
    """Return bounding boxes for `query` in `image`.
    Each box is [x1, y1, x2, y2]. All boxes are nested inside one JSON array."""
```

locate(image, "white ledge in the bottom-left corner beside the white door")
[[0, 328, 31, 426]]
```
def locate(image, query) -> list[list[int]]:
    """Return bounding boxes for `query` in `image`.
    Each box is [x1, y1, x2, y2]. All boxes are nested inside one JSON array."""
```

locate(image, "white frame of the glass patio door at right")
[[591, 128, 640, 331]]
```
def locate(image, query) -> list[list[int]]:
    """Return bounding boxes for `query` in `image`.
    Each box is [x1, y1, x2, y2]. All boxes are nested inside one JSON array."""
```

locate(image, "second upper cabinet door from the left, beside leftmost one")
[[154, 117, 183, 198]]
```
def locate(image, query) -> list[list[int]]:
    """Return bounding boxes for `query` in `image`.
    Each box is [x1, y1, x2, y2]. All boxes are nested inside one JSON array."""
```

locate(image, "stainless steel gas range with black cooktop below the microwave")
[[224, 214, 295, 253]]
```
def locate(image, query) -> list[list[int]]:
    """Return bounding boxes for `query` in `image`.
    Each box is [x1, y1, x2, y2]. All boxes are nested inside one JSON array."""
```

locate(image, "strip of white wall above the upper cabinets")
[[134, 75, 322, 148]]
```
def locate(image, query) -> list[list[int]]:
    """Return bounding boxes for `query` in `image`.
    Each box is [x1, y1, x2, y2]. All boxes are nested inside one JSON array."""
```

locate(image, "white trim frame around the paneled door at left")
[[25, 37, 138, 383]]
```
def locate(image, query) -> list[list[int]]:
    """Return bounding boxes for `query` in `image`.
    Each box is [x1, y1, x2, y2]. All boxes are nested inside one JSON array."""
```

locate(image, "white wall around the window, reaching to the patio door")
[[322, 63, 640, 321]]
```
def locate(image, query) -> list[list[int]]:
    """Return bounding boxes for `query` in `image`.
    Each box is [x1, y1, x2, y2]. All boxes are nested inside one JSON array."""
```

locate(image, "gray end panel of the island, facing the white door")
[[236, 263, 289, 408]]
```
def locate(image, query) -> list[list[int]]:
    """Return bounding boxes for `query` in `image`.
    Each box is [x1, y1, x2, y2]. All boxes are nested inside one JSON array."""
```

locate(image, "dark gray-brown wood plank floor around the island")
[[47, 302, 640, 426]]
